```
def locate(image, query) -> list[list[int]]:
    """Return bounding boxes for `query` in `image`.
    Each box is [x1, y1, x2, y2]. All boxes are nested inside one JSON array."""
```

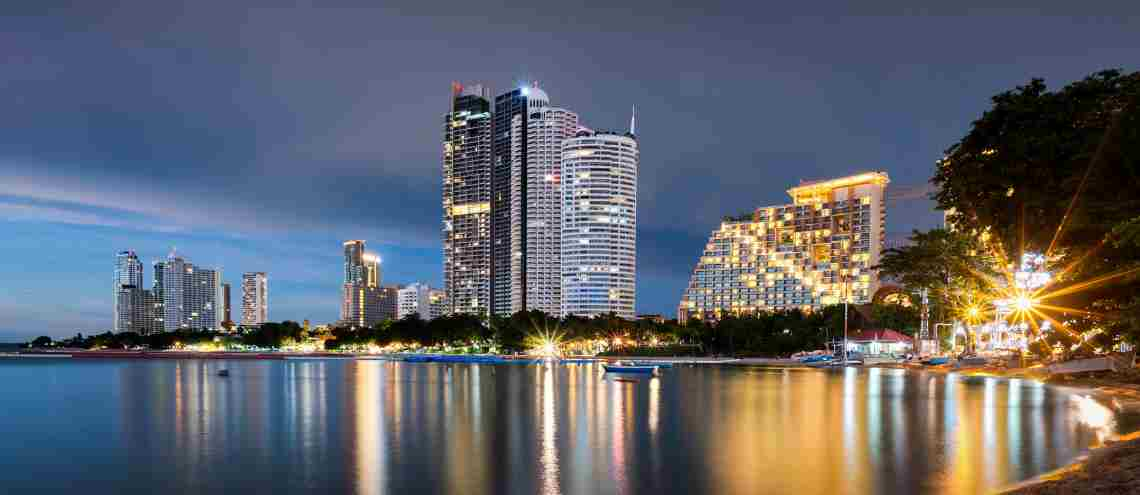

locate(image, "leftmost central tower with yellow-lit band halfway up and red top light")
[[442, 84, 492, 315]]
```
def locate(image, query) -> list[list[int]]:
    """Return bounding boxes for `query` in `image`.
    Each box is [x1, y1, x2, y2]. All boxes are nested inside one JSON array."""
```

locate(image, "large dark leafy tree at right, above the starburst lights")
[[931, 71, 1140, 342]]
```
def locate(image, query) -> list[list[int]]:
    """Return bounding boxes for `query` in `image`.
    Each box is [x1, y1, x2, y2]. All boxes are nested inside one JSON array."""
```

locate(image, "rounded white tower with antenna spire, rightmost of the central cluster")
[[561, 127, 638, 319]]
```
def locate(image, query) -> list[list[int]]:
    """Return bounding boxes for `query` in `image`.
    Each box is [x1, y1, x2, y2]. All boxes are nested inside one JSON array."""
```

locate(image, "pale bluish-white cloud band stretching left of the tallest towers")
[[0, 164, 439, 248]]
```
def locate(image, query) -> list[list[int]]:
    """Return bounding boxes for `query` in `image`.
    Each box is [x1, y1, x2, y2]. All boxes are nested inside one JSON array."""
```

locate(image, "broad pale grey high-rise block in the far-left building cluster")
[[154, 253, 225, 332]]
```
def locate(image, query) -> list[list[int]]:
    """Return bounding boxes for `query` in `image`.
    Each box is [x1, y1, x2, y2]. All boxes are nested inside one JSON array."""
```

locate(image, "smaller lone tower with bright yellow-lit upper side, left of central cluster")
[[341, 241, 397, 327]]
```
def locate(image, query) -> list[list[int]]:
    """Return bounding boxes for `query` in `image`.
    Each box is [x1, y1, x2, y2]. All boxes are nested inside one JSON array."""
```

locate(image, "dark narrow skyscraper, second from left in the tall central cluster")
[[491, 84, 549, 315]]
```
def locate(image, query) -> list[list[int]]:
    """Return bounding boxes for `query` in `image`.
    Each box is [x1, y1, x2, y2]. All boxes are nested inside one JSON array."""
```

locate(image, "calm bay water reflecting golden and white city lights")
[[0, 360, 1118, 494]]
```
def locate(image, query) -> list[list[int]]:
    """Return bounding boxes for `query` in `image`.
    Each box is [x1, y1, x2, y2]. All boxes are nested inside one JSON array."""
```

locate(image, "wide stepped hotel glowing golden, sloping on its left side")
[[677, 172, 889, 322]]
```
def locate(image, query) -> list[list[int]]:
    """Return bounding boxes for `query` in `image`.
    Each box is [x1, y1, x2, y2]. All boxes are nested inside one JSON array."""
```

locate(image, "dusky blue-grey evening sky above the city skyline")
[[0, 0, 1140, 341]]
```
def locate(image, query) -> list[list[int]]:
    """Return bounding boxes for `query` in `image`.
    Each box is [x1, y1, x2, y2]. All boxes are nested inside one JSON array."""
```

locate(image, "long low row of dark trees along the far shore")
[[20, 305, 918, 357]]
